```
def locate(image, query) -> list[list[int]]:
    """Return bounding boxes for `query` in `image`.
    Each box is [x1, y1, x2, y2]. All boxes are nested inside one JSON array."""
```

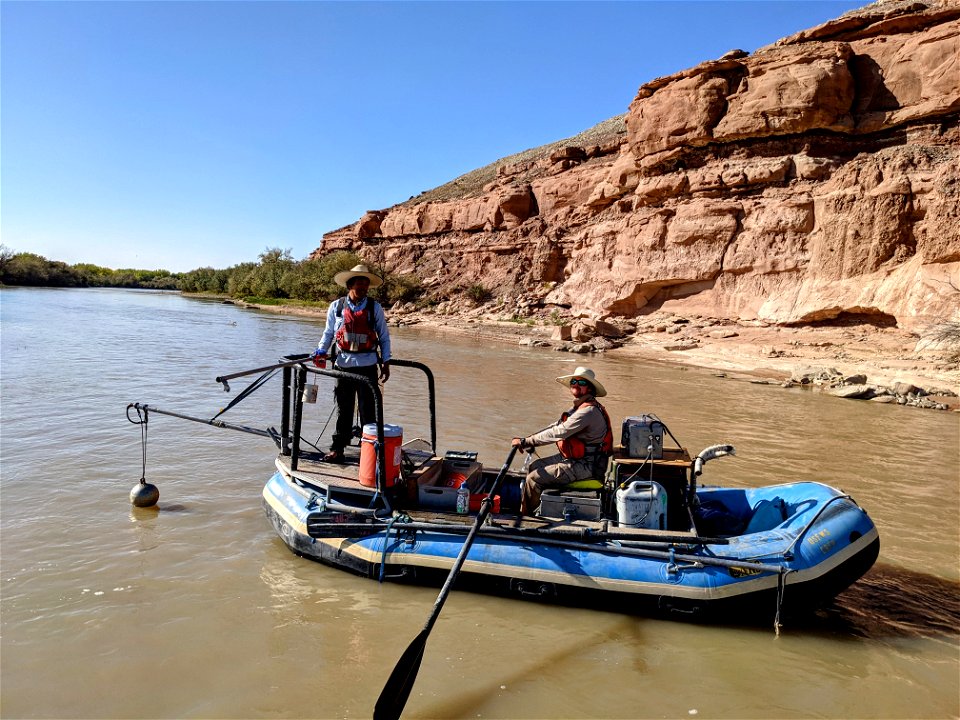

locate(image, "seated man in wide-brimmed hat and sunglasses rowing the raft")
[[512, 367, 613, 515]]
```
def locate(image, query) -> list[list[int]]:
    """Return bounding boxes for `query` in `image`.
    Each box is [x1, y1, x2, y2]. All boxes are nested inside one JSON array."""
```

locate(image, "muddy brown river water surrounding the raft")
[[0, 289, 960, 718]]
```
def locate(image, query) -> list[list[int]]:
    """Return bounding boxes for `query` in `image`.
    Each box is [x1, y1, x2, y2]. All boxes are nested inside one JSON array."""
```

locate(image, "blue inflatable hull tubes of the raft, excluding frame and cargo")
[[263, 449, 879, 619]]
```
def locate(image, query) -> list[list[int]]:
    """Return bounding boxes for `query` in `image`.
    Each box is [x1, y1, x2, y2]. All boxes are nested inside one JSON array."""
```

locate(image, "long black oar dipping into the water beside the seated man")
[[373, 447, 517, 720]]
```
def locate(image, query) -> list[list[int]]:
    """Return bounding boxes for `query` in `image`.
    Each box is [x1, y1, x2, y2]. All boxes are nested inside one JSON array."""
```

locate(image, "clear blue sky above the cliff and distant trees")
[[0, 0, 866, 271]]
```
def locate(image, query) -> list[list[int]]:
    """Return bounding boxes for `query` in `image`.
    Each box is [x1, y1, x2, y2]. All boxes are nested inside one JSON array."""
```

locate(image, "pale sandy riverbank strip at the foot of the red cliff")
[[236, 302, 960, 411]]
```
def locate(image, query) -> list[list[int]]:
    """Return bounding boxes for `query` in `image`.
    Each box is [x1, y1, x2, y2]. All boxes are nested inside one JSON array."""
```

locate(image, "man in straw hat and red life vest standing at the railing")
[[313, 265, 390, 463]]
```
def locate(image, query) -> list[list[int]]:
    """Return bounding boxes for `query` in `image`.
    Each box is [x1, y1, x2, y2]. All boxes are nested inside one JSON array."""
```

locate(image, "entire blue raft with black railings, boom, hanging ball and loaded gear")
[[127, 355, 880, 618]]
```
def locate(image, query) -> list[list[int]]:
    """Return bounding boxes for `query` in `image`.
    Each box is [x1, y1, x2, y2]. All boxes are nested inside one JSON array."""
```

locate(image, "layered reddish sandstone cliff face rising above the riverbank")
[[318, 0, 960, 328]]
